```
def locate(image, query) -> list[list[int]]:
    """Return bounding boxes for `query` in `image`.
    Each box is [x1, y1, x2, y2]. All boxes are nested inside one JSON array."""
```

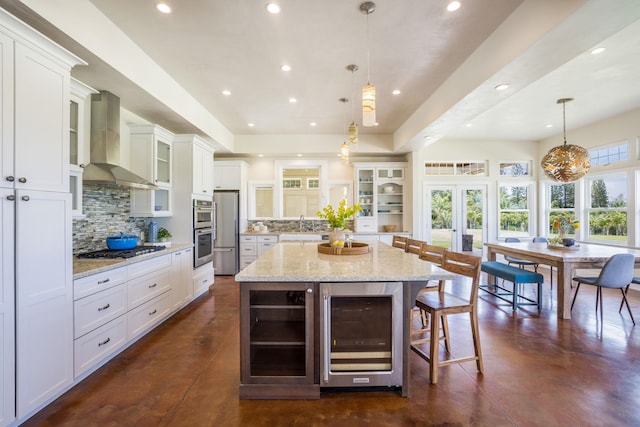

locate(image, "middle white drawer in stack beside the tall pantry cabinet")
[[73, 284, 127, 338]]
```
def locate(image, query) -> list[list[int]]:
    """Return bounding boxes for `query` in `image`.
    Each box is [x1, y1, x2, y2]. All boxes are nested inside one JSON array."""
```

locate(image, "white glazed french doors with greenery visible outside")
[[424, 185, 487, 251]]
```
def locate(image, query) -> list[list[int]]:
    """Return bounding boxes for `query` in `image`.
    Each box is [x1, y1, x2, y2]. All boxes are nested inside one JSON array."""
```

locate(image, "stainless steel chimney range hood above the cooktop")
[[82, 91, 158, 189]]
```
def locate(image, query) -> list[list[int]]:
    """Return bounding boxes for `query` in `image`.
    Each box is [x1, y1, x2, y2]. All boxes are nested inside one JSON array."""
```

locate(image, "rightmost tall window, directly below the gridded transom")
[[587, 174, 628, 245]]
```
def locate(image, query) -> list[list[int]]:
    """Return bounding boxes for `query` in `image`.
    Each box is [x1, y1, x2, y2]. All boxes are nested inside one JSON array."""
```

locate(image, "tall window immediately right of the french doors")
[[498, 184, 532, 237]]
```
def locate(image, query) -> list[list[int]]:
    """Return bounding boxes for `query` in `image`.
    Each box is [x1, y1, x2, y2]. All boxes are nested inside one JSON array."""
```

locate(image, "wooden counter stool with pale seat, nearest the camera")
[[411, 251, 484, 384]]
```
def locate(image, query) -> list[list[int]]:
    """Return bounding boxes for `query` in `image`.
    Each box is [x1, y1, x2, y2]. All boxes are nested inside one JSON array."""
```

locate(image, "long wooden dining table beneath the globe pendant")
[[485, 241, 640, 319]]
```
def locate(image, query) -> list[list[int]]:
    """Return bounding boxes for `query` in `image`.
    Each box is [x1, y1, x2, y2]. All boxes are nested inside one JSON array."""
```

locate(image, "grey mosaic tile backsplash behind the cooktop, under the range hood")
[[73, 185, 151, 255]]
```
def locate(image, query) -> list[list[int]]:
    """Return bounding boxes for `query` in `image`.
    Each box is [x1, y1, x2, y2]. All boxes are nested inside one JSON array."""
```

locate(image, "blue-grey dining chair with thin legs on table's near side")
[[571, 254, 636, 325]]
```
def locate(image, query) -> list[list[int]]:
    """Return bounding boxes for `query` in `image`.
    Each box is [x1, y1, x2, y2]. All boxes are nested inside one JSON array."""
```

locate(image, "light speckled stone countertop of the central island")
[[235, 241, 453, 282]]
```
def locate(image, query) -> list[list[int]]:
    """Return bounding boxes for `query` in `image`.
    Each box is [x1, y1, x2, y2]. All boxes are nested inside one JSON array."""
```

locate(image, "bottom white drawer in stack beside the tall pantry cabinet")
[[73, 316, 127, 377]]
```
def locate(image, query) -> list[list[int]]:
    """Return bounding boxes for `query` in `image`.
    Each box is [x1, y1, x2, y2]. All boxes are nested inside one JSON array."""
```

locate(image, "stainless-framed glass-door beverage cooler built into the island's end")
[[320, 282, 403, 387]]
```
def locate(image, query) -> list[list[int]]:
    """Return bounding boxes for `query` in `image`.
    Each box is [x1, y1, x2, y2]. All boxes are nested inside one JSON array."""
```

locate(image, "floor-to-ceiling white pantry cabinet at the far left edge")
[[0, 9, 83, 426]]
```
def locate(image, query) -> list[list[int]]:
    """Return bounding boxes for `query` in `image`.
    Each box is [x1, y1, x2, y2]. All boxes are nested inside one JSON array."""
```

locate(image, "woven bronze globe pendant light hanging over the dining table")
[[540, 98, 591, 182]]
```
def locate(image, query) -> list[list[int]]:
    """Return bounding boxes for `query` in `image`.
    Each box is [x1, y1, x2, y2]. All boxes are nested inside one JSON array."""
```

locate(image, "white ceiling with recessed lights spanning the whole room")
[[0, 0, 640, 155]]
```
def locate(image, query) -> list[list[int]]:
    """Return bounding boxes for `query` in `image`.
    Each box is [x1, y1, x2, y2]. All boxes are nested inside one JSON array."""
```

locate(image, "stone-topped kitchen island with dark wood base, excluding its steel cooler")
[[236, 241, 453, 399]]
